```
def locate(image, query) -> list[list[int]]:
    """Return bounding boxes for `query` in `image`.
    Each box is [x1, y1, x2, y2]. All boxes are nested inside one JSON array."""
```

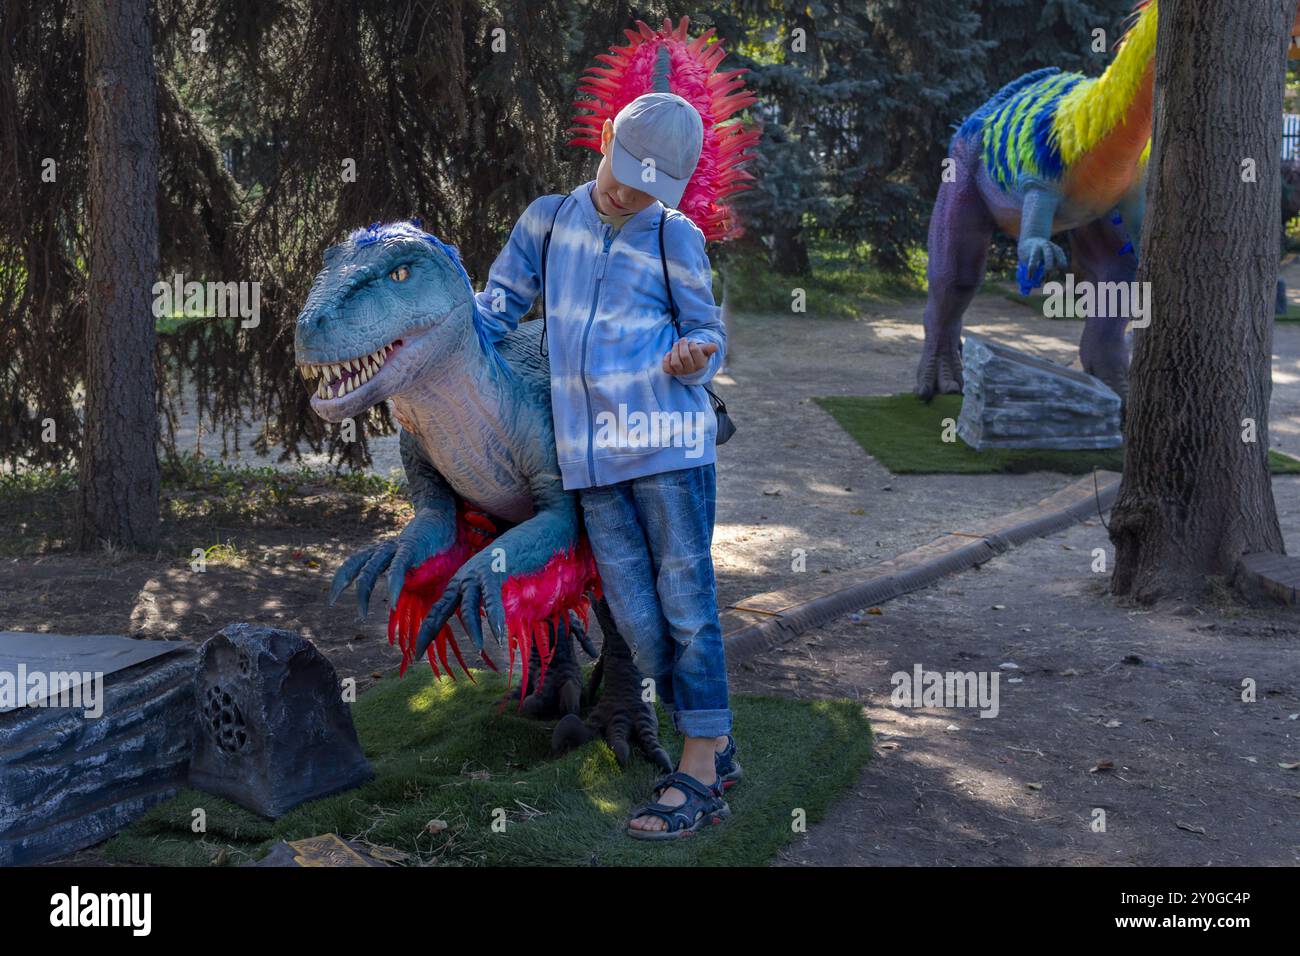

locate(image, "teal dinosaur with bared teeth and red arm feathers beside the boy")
[[294, 222, 671, 770]]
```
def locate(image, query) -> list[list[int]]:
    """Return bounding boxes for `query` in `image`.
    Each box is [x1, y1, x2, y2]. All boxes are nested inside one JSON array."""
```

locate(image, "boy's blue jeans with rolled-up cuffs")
[[579, 464, 732, 737]]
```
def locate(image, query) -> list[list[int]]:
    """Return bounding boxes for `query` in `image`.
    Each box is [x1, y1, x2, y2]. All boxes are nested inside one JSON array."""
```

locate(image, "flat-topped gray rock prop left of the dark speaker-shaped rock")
[[0, 631, 196, 866]]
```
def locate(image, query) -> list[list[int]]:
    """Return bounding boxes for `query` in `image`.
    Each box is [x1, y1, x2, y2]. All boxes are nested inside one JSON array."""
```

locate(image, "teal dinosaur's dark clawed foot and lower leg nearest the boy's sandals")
[[551, 620, 672, 773]]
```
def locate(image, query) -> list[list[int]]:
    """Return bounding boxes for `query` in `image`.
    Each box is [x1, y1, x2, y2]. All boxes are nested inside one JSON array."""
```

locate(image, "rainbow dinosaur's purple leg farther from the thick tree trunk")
[[915, 140, 993, 402]]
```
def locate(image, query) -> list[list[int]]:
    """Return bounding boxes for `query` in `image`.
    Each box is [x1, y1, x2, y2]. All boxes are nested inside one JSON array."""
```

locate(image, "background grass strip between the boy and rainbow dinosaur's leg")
[[718, 239, 926, 319]]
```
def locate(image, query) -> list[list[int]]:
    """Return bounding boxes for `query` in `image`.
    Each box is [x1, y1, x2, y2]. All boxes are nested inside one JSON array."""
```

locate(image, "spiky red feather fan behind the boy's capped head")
[[568, 17, 759, 241]]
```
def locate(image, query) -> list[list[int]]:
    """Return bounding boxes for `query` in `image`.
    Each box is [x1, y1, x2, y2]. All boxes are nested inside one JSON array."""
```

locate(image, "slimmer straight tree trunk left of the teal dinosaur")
[[77, 0, 161, 550]]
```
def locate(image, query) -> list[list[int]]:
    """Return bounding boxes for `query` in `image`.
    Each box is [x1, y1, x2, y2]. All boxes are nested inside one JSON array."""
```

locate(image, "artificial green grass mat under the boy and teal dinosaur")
[[104, 669, 871, 866]]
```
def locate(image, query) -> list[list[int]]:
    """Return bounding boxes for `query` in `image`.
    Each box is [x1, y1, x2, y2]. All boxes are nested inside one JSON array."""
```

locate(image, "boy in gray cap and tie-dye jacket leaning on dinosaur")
[[476, 92, 740, 839]]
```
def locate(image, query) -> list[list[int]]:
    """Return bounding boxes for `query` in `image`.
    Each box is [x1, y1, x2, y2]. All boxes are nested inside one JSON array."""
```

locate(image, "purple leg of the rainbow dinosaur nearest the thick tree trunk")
[[1070, 216, 1138, 399]]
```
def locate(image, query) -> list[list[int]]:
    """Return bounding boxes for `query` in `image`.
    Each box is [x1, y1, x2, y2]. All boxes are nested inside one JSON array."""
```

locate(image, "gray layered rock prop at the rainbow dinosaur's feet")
[[957, 336, 1125, 451]]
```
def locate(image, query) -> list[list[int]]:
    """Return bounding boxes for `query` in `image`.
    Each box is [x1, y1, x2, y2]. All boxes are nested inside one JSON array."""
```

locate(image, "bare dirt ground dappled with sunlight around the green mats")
[[10, 281, 1300, 865]]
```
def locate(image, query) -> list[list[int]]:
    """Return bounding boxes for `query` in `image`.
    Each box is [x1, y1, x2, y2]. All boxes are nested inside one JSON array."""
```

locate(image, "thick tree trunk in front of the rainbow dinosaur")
[[1110, 0, 1296, 601]]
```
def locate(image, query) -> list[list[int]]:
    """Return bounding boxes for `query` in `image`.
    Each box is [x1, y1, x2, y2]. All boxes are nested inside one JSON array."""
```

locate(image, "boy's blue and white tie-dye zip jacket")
[[476, 182, 727, 489]]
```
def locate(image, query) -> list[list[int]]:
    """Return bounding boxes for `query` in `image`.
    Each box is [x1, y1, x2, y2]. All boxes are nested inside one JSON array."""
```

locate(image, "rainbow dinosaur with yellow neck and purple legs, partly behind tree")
[[915, 0, 1157, 401]]
